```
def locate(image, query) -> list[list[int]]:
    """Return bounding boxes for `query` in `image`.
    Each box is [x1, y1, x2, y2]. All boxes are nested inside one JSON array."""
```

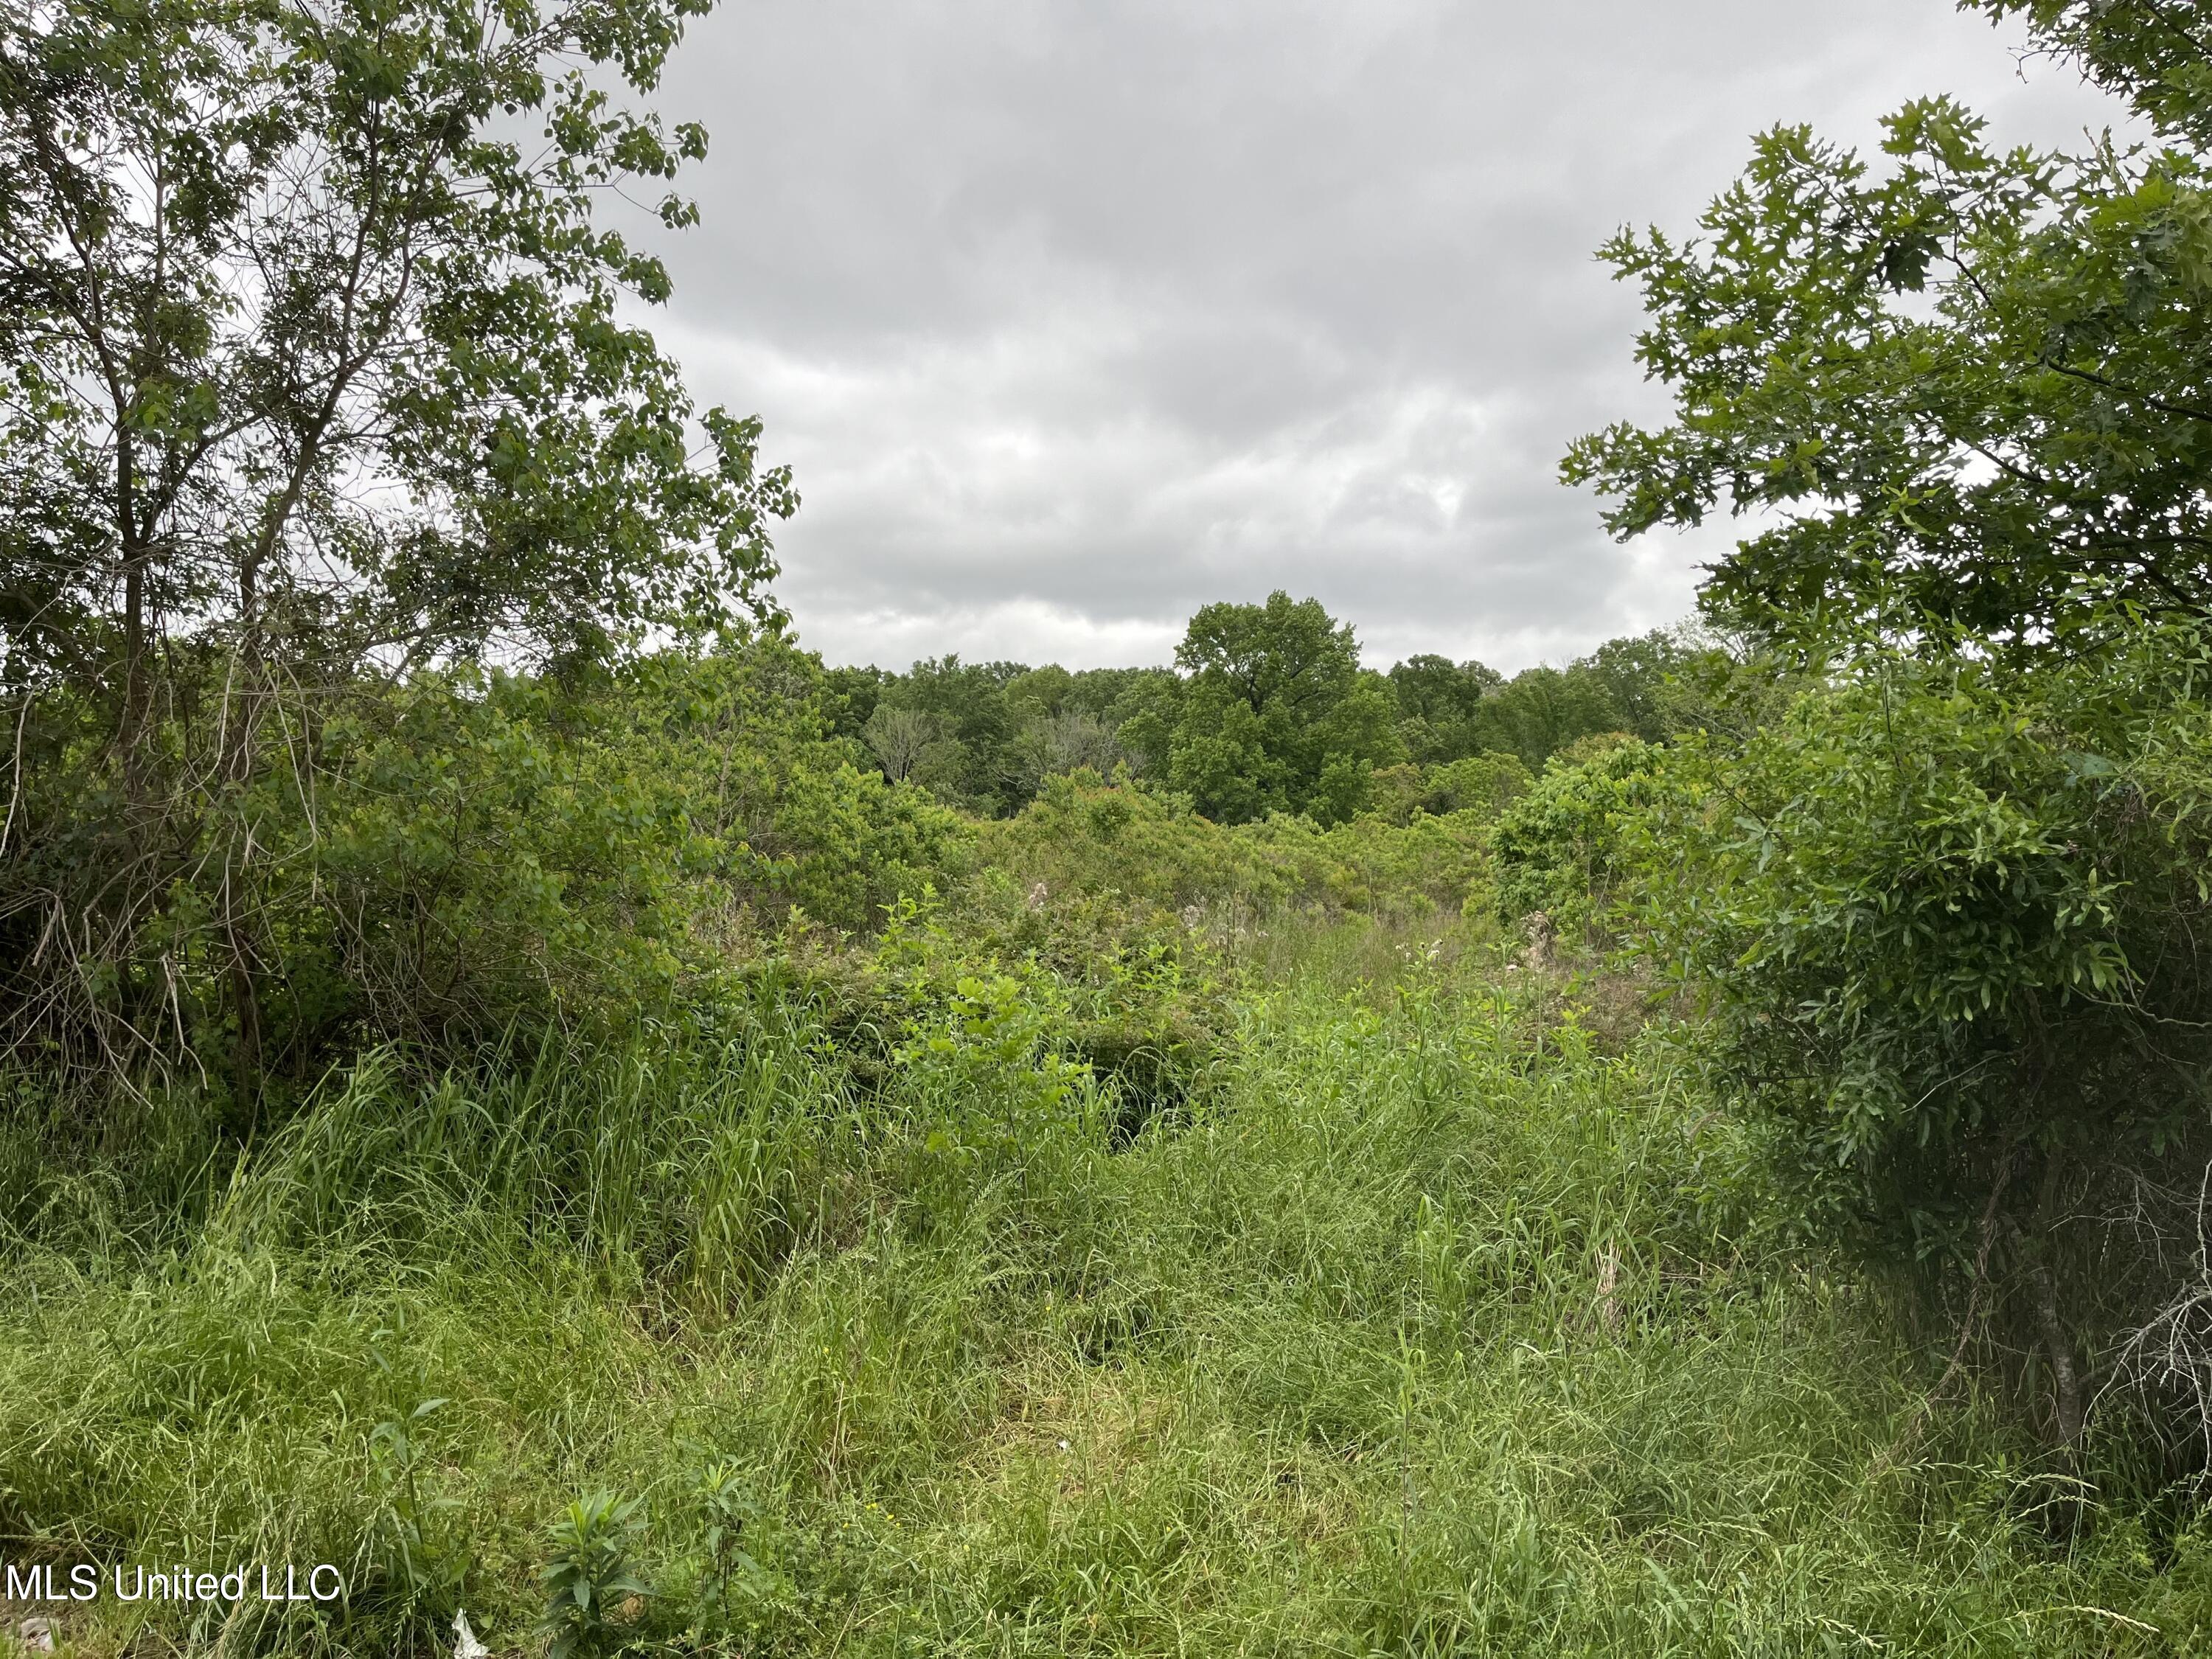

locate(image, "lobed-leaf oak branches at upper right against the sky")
[[1564, 0, 2212, 650]]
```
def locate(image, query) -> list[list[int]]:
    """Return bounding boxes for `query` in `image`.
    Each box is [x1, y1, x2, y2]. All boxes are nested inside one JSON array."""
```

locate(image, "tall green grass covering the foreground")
[[0, 929, 2212, 1657]]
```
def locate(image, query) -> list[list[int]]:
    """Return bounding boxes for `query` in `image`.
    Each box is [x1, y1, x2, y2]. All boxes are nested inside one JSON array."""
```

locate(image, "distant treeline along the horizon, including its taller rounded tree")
[[827, 593, 1728, 823]]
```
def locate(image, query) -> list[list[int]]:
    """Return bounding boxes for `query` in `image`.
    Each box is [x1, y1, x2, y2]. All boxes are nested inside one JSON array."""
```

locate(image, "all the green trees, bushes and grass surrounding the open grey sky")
[[0, 0, 2212, 1659]]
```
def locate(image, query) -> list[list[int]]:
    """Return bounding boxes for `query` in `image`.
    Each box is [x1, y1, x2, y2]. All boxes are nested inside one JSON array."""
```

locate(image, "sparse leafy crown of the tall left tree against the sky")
[[0, 0, 790, 695]]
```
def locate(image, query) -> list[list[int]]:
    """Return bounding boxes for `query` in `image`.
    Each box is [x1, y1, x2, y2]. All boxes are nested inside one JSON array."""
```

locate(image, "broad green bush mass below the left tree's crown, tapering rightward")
[[296, 641, 964, 1040]]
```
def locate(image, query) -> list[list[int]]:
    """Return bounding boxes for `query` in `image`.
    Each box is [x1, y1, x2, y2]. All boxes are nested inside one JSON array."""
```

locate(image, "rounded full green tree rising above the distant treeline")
[[1130, 593, 1405, 823]]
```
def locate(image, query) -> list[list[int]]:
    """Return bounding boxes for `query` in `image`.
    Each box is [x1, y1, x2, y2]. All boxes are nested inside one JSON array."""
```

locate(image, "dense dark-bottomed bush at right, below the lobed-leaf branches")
[[1648, 626, 2212, 1440]]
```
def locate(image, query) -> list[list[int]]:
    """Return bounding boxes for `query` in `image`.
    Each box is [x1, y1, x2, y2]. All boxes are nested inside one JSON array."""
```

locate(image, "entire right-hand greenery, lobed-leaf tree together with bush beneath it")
[[1557, 0, 2212, 1444]]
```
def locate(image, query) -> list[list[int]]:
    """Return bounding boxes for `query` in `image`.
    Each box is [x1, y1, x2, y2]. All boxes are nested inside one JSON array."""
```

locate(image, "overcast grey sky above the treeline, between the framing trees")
[[637, 0, 2112, 670]]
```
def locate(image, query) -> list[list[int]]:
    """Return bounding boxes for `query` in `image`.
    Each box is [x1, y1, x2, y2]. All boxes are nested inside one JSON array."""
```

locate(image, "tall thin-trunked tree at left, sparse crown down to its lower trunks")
[[0, 0, 794, 1084]]
